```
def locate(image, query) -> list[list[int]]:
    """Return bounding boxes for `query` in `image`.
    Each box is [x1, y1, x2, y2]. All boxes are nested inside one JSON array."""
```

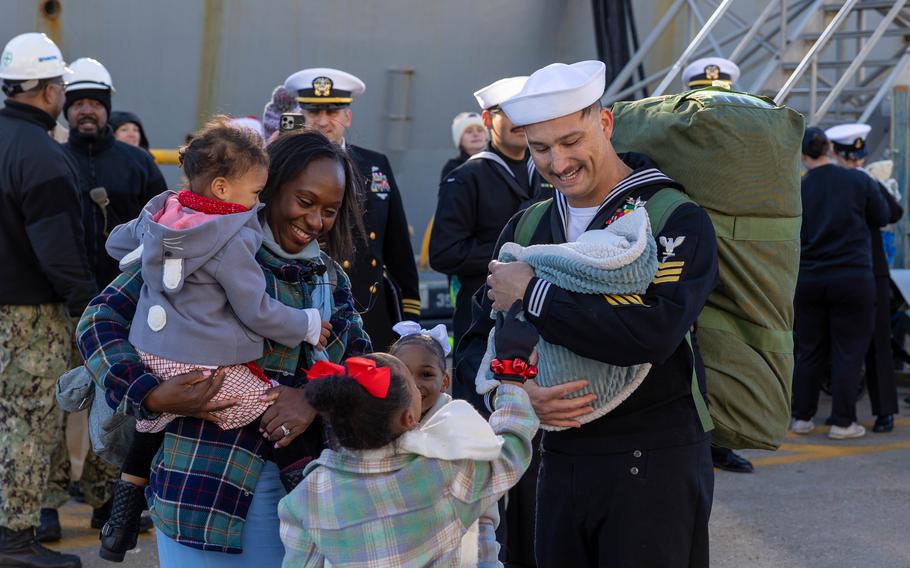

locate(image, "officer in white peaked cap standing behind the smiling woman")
[[284, 67, 420, 351]]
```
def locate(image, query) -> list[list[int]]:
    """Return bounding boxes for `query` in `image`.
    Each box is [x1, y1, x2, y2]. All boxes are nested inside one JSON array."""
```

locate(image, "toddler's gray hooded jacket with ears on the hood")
[[106, 191, 311, 365]]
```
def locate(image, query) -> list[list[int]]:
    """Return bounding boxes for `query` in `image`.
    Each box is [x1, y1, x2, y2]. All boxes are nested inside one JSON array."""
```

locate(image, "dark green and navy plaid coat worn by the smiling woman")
[[76, 248, 372, 553]]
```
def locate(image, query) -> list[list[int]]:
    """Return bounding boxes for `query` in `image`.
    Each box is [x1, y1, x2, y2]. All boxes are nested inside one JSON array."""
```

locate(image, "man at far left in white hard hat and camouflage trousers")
[[0, 33, 95, 568]]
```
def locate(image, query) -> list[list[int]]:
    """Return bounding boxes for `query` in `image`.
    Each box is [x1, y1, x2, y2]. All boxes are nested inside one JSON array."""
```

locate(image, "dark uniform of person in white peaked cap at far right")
[[866, 184, 904, 416]]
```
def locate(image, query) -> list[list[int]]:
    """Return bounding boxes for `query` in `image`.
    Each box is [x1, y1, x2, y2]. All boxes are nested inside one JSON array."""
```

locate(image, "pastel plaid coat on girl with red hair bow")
[[278, 384, 539, 568]]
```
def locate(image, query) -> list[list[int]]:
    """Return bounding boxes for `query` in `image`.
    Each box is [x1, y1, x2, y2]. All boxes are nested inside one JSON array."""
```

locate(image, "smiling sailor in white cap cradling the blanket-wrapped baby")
[[460, 61, 718, 567]]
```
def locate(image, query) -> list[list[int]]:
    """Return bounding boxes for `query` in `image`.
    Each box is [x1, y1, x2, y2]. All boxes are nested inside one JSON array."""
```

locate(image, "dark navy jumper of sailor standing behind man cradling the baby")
[[429, 140, 553, 366]]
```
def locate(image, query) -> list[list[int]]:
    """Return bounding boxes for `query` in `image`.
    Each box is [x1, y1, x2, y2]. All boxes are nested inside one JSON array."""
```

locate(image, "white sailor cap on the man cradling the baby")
[[500, 61, 607, 126]]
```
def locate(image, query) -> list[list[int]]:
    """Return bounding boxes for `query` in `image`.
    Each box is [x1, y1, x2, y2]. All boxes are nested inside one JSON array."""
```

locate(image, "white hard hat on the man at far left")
[[0, 32, 70, 81]]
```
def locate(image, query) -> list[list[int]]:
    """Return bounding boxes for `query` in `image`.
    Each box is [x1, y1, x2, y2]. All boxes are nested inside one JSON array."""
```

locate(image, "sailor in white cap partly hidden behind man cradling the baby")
[[429, 76, 553, 566]]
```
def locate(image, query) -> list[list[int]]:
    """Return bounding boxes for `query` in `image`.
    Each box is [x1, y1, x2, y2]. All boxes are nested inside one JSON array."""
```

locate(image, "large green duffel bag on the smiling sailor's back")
[[613, 87, 804, 449]]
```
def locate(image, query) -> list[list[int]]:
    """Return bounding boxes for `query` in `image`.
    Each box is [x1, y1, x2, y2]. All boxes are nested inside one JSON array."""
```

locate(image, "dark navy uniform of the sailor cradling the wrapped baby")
[[456, 154, 718, 568]]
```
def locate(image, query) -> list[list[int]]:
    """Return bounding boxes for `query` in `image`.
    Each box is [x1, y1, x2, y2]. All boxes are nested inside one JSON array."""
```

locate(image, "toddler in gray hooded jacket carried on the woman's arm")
[[100, 120, 331, 561]]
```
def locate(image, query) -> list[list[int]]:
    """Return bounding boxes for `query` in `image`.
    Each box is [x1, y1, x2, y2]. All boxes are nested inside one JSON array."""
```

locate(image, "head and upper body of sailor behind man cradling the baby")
[[429, 77, 553, 378]]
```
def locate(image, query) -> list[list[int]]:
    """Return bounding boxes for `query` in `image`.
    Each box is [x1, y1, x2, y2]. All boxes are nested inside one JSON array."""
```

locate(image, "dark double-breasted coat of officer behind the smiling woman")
[[341, 145, 420, 351]]
